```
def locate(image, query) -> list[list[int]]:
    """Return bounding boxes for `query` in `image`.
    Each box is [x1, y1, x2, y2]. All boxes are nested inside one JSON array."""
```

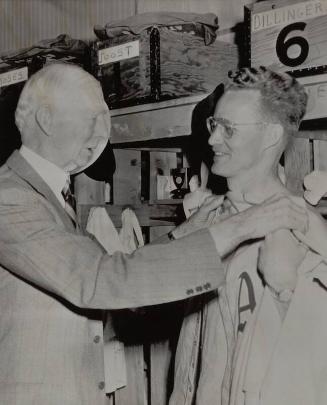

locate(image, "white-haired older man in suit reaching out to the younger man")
[[0, 64, 307, 405]]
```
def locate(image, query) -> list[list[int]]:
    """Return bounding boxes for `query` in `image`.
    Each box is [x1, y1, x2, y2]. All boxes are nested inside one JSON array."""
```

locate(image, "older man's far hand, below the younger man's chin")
[[173, 195, 224, 239]]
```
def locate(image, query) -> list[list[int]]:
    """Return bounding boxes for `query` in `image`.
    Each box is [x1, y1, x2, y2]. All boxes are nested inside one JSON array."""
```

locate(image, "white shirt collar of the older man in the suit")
[[19, 145, 69, 207]]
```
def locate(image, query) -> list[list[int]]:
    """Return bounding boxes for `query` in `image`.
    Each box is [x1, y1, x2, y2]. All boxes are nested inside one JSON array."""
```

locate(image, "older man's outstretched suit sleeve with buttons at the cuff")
[[0, 189, 224, 309]]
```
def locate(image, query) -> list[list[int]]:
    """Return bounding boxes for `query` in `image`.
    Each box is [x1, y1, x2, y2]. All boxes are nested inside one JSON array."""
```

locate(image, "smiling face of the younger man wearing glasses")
[[207, 89, 265, 179]]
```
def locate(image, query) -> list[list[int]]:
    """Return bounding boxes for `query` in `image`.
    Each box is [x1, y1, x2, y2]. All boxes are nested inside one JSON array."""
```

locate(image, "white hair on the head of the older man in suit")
[[15, 62, 99, 137]]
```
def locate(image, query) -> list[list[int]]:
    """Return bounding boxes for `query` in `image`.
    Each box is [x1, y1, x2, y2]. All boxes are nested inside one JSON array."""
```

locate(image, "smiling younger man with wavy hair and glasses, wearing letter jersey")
[[170, 67, 327, 405]]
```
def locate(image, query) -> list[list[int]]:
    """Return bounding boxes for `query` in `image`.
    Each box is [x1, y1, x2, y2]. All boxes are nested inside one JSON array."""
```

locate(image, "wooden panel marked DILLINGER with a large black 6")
[[245, 0, 327, 75]]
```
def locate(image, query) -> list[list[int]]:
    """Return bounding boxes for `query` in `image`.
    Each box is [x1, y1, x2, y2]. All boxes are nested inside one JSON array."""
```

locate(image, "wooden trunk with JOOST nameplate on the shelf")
[[91, 19, 238, 108]]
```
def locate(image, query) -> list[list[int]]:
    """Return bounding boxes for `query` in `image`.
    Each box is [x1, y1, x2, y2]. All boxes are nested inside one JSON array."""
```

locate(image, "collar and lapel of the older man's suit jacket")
[[6, 150, 76, 232]]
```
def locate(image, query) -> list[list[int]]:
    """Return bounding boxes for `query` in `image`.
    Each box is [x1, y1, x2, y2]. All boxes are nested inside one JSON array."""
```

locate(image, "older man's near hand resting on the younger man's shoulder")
[[211, 195, 308, 257]]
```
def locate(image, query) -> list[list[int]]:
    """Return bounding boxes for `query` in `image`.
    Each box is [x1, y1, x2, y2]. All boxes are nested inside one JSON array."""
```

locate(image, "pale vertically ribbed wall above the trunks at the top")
[[0, 0, 254, 53]]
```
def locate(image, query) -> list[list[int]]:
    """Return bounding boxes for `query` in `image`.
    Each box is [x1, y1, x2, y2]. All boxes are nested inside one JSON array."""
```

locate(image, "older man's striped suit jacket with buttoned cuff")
[[0, 151, 223, 405]]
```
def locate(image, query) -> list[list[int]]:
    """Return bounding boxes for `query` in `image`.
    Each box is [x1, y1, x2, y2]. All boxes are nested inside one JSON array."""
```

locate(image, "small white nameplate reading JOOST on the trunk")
[[98, 41, 140, 66]]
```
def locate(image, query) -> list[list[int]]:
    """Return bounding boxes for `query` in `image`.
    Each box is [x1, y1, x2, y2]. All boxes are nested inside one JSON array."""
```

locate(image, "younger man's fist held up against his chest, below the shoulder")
[[258, 229, 308, 291]]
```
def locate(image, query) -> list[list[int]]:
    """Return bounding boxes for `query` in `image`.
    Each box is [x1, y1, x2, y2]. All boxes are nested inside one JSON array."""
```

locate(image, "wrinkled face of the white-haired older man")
[[52, 79, 110, 173]]
